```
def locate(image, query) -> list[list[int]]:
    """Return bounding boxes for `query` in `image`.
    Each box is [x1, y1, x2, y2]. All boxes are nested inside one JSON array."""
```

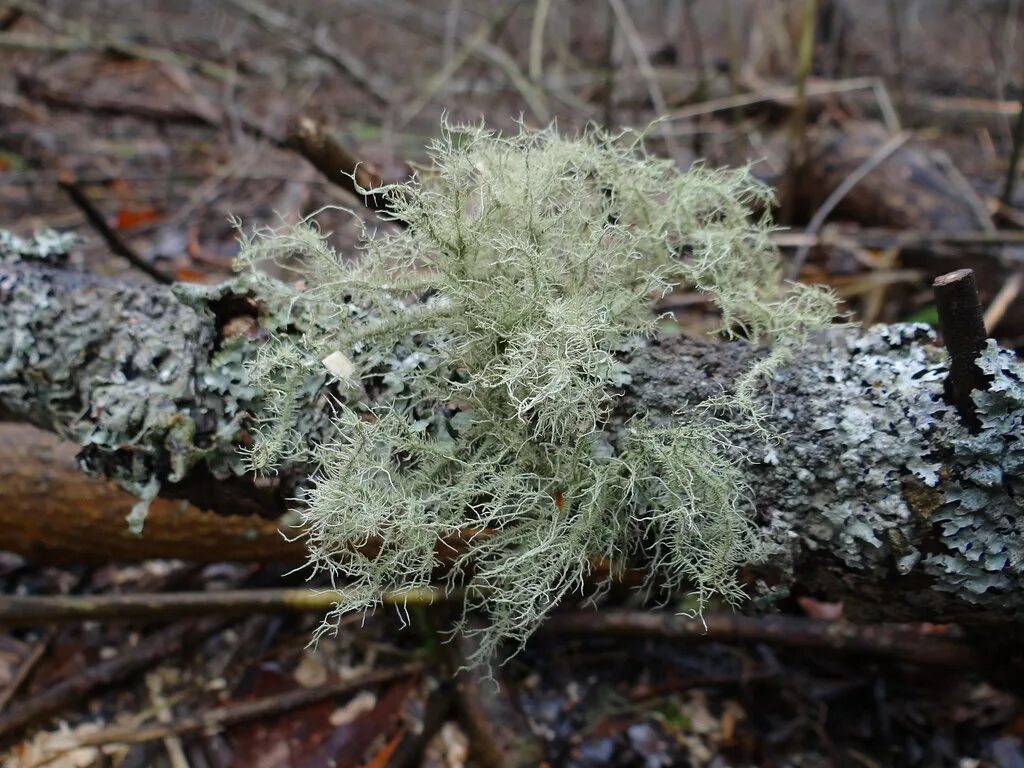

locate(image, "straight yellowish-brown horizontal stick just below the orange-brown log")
[[0, 588, 456, 627]]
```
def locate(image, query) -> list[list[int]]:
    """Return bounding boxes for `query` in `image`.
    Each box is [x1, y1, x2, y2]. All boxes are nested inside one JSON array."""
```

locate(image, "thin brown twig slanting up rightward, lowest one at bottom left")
[[48, 663, 423, 749]]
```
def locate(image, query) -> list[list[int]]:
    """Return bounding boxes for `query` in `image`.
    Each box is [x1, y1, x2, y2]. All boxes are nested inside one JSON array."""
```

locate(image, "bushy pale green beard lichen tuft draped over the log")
[[235, 123, 835, 662]]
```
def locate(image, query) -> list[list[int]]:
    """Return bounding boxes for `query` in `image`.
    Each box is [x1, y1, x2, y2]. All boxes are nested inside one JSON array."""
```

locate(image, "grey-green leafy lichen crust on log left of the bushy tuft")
[[0, 237, 335, 527]]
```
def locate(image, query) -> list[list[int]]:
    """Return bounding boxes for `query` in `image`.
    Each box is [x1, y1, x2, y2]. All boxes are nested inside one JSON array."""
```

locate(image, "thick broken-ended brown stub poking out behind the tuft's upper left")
[[285, 117, 400, 223]]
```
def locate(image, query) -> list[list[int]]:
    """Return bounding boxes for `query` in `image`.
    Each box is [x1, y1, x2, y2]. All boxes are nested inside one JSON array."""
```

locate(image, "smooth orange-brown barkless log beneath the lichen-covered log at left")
[[0, 424, 305, 564]]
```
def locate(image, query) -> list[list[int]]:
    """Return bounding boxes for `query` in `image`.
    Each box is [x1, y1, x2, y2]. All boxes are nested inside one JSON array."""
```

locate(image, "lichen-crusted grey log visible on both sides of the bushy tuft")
[[0, 262, 1024, 624]]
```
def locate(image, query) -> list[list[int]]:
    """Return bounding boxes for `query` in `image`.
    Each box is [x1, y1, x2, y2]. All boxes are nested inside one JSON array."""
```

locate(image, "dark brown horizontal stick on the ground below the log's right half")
[[540, 610, 983, 667]]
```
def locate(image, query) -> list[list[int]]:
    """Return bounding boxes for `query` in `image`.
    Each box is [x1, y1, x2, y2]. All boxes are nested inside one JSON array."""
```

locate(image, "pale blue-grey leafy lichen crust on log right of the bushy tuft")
[[729, 326, 1024, 617]]
